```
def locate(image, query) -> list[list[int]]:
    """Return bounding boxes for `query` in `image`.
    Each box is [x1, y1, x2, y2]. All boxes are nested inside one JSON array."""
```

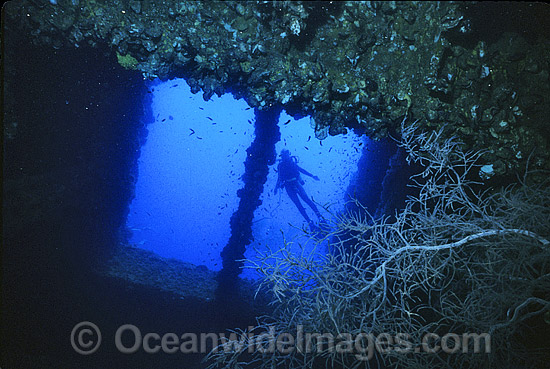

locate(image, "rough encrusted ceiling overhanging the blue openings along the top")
[[9, 0, 550, 177]]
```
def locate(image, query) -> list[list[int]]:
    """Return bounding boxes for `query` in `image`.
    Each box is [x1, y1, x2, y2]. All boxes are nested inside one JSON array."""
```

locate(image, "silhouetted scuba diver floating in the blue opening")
[[274, 149, 323, 228]]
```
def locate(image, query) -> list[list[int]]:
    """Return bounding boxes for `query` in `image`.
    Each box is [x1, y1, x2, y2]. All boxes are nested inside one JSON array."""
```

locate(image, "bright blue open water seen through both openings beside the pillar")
[[127, 79, 369, 277]]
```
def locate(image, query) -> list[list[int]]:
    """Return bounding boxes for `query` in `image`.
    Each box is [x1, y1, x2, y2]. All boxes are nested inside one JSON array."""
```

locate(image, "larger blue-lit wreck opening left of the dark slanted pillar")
[[127, 79, 254, 271]]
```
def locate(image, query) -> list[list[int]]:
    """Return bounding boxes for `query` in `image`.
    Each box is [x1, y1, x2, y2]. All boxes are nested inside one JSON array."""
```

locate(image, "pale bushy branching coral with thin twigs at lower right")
[[209, 119, 550, 368]]
